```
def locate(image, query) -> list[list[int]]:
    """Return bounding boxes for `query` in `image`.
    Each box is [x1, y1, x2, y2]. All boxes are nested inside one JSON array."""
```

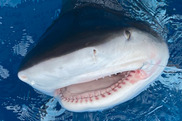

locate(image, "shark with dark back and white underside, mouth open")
[[18, 8, 169, 112]]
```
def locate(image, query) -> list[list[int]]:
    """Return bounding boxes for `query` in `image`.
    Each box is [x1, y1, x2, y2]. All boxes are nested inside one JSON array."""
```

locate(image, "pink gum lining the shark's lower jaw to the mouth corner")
[[55, 70, 149, 103]]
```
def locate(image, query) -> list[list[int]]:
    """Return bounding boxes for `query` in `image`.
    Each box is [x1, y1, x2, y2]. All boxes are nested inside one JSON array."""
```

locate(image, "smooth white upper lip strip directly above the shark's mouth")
[[53, 60, 145, 89]]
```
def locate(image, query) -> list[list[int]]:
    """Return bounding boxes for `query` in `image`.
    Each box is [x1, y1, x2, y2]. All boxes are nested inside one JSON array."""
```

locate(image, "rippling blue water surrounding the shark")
[[0, 0, 182, 121]]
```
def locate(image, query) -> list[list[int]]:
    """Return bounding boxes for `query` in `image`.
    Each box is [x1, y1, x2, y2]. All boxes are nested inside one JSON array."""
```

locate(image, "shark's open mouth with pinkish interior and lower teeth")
[[56, 70, 147, 103]]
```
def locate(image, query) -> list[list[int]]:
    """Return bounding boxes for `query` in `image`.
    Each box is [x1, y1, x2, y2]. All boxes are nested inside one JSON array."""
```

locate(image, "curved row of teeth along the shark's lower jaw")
[[55, 70, 148, 103]]
